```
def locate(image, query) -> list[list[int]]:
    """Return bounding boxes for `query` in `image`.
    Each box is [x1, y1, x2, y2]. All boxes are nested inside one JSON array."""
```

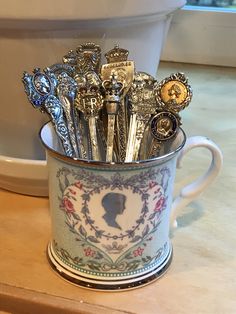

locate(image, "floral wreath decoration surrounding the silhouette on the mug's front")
[[53, 167, 170, 272]]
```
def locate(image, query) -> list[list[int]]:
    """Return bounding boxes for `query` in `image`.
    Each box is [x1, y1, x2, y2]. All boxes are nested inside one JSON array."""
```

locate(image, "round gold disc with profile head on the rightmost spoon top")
[[160, 80, 188, 106]]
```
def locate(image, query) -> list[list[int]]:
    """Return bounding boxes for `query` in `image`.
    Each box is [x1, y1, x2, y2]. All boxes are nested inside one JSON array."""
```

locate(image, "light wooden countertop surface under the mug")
[[0, 63, 236, 314]]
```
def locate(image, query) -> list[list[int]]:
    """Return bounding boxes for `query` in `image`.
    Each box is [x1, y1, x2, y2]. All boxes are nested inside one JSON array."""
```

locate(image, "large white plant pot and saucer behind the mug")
[[0, 0, 185, 195]]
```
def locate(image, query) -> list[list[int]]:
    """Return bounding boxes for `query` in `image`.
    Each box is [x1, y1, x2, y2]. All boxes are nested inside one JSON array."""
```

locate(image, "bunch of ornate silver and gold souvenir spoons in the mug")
[[22, 43, 192, 162]]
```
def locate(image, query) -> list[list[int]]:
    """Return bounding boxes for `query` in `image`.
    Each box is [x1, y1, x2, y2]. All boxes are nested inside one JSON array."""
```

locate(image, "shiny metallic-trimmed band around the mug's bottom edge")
[[47, 243, 173, 291]]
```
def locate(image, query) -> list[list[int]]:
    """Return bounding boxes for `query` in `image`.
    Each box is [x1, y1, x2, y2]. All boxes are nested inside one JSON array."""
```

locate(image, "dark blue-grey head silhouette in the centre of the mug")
[[102, 192, 126, 229]]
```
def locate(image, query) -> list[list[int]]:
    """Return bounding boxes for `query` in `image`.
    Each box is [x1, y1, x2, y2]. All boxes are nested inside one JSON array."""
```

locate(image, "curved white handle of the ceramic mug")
[[171, 136, 223, 227]]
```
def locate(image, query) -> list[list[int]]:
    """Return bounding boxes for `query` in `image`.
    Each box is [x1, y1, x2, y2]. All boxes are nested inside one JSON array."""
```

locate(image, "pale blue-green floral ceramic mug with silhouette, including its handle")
[[40, 123, 222, 290]]
